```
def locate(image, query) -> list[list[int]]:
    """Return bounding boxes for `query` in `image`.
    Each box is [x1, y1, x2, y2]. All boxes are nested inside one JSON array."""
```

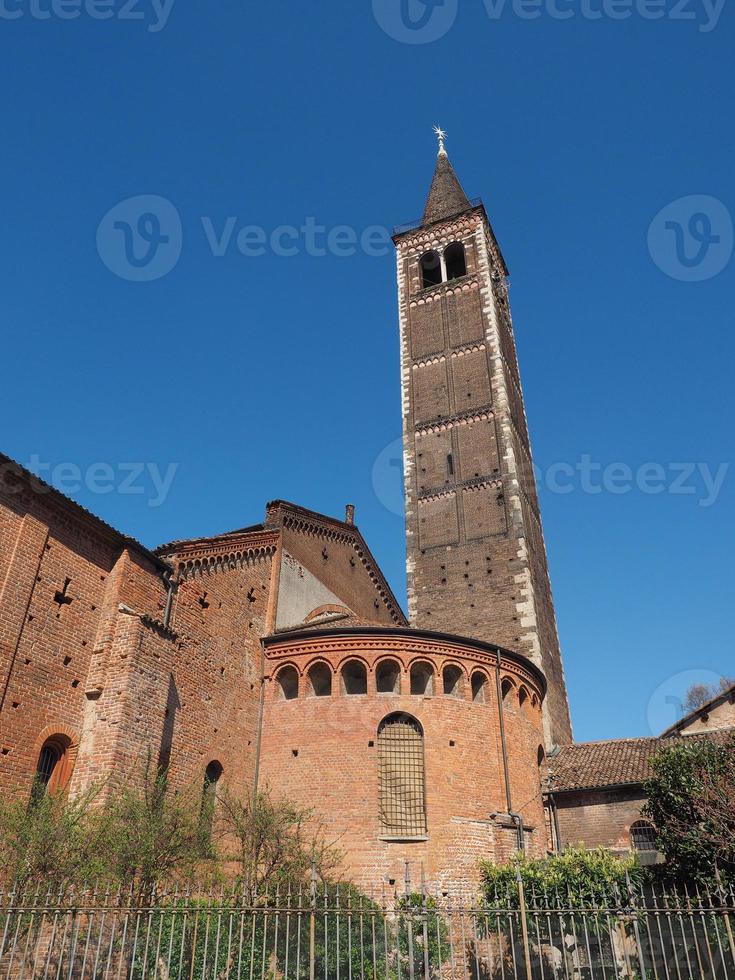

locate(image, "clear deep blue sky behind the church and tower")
[[0, 0, 735, 739]]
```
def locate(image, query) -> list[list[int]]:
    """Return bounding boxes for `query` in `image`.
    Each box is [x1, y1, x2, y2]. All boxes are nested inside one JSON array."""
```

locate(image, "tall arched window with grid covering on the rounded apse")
[[378, 713, 426, 837]]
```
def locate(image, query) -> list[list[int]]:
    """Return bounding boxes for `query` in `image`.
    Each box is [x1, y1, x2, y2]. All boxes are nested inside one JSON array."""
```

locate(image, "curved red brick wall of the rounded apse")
[[261, 630, 546, 888]]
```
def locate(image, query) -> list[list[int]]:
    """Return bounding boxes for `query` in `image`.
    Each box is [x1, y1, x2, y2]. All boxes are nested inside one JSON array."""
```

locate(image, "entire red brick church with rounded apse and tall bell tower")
[[0, 131, 720, 890]]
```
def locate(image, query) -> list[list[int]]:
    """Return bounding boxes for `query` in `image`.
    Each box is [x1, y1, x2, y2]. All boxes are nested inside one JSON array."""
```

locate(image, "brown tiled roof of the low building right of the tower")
[[546, 738, 665, 792]]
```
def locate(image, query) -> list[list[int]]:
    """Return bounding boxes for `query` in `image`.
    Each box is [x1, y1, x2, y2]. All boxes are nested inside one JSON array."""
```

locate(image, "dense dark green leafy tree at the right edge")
[[644, 735, 735, 881]]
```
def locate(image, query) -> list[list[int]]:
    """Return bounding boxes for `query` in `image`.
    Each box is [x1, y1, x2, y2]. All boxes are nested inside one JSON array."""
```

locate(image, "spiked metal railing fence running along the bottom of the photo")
[[0, 883, 735, 980]]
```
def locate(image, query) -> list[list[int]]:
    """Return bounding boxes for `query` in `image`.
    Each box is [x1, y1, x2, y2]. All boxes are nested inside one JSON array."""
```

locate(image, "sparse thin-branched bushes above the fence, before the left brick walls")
[[0, 759, 340, 899]]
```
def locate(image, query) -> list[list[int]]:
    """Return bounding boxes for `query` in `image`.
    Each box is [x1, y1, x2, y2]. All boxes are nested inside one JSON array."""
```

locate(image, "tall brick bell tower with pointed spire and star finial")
[[393, 130, 572, 747]]
